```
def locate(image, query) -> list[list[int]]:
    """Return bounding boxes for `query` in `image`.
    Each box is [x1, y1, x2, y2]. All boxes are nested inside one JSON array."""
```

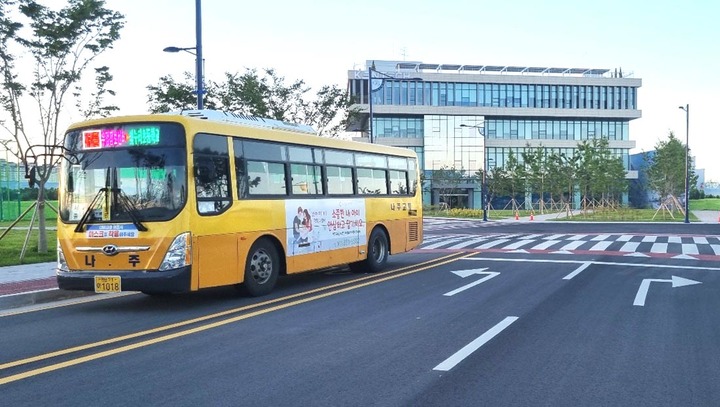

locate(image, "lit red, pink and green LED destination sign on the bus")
[[83, 126, 160, 150]]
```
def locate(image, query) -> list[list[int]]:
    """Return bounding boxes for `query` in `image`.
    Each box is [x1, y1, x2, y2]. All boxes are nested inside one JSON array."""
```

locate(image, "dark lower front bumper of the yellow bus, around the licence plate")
[[56, 266, 191, 293]]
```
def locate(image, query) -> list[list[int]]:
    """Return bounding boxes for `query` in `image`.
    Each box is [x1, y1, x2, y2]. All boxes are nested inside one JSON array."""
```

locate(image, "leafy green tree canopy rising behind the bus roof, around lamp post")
[[147, 68, 357, 136]]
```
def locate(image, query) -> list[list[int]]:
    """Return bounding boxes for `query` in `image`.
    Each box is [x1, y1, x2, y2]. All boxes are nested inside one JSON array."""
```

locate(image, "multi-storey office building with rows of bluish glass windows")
[[348, 61, 642, 208]]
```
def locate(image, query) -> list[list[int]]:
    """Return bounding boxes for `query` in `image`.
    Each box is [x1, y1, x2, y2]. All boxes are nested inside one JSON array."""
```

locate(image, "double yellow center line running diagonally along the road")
[[0, 253, 474, 385]]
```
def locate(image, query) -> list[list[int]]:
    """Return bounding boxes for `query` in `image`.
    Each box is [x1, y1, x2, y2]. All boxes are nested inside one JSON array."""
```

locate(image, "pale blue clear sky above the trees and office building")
[[36, 0, 720, 181]]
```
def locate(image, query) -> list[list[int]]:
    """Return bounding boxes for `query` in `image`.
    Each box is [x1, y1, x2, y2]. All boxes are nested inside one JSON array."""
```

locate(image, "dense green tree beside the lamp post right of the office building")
[[645, 131, 698, 199]]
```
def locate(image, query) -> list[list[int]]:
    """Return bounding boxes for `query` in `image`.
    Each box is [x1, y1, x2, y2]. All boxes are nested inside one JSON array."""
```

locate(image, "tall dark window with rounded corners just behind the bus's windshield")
[[193, 134, 231, 215]]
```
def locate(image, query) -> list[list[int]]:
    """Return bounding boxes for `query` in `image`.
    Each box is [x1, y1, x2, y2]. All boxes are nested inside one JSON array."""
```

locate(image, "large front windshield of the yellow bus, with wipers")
[[59, 125, 187, 223]]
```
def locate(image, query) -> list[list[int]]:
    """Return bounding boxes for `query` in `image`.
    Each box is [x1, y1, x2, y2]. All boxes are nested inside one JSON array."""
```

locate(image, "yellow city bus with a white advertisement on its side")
[[57, 110, 422, 296]]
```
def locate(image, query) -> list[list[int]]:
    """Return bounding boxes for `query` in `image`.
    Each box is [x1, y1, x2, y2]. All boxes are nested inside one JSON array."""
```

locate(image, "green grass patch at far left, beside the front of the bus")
[[0, 228, 57, 266]]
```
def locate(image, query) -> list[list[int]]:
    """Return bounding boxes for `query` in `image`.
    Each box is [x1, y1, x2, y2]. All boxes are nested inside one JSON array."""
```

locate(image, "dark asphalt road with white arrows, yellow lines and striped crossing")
[[0, 222, 720, 406]]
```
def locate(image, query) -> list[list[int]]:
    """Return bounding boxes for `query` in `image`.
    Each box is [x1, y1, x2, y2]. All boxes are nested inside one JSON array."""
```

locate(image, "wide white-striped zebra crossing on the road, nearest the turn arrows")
[[419, 233, 720, 258]]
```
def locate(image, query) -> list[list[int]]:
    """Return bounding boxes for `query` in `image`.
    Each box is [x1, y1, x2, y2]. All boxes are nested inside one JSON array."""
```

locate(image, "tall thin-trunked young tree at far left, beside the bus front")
[[0, 0, 124, 253]]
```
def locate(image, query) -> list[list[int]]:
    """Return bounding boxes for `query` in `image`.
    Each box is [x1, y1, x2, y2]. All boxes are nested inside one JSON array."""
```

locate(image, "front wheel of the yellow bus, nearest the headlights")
[[243, 239, 280, 297]]
